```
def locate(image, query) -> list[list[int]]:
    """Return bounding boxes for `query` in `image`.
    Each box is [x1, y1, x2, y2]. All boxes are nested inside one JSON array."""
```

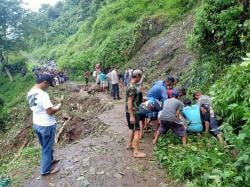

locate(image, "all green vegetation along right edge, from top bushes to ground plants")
[[155, 0, 250, 186]]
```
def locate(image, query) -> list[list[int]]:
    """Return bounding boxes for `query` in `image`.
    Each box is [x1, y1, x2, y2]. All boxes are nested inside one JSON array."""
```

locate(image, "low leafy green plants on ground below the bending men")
[[154, 134, 242, 186]]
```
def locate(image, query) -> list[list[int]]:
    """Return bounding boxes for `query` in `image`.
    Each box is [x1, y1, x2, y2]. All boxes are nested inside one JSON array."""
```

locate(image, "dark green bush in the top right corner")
[[191, 0, 250, 64]]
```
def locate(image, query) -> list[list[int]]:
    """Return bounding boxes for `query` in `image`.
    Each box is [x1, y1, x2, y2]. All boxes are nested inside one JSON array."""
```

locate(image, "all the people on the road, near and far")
[[27, 64, 224, 176]]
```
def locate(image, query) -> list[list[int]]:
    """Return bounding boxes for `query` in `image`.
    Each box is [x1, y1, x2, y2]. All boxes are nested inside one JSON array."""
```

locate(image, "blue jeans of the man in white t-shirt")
[[33, 125, 56, 175]]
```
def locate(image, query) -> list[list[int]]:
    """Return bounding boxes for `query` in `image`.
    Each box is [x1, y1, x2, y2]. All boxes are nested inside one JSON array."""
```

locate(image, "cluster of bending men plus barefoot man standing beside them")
[[126, 70, 224, 158]]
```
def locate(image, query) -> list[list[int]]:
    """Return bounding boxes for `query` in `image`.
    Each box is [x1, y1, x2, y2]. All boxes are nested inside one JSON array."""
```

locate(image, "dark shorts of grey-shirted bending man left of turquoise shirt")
[[159, 120, 186, 137]]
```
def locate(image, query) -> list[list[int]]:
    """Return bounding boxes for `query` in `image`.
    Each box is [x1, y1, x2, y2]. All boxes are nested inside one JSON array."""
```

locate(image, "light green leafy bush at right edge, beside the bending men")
[[211, 54, 250, 185]]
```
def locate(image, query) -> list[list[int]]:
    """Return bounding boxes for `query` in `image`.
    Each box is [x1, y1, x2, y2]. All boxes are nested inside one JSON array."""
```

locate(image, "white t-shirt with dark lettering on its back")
[[27, 88, 56, 126]]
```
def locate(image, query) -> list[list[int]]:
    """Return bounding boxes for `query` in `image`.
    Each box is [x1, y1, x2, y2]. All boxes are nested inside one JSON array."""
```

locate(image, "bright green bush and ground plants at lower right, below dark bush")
[[155, 58, 250, 186]]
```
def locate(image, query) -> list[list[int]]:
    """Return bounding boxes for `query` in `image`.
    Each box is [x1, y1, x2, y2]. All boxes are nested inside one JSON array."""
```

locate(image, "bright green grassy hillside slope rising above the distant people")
[[27, 0, 198, 78]]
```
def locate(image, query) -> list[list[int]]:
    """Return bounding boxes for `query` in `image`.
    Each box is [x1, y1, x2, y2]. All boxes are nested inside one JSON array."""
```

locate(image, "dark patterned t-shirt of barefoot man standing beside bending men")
[[126, 83, 140, 114]]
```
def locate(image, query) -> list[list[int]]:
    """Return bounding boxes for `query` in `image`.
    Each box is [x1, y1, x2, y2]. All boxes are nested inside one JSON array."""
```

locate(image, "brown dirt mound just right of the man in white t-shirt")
[[56, 86, 111, 143]]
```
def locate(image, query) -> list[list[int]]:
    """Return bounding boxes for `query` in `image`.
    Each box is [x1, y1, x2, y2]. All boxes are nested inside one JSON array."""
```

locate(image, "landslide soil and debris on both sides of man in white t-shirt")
[[0, 84, 111, 157]]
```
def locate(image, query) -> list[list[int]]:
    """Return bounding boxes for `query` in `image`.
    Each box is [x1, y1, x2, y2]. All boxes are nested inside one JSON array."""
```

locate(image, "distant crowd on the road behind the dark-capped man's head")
[[32, 67, 68, 85]]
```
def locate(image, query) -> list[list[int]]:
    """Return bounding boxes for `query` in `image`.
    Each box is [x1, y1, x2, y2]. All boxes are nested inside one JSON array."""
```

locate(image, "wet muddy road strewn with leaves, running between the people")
[[25, 85, 172, 187]]
